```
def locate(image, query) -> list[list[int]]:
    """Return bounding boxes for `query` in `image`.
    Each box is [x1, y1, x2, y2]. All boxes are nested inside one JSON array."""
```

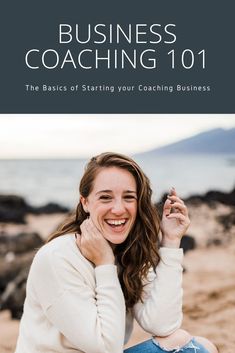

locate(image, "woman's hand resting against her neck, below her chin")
[[76, 218, 114, 266]]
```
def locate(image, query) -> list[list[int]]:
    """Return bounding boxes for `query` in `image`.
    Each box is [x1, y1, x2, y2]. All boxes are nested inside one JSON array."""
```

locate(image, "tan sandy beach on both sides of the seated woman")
[[0, 197, 235, 353]]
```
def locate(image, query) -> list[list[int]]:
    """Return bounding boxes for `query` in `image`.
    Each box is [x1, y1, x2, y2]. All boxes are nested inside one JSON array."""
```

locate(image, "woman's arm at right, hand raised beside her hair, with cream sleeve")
[[134, 188, 190, 336]]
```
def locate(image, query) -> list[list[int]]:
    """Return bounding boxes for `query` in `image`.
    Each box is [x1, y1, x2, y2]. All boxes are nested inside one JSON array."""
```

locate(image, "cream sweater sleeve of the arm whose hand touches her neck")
[[33, 248, 125, 353]]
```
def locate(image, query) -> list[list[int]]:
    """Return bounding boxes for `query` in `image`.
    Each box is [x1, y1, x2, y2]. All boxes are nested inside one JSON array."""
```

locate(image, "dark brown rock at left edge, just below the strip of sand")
[[0, 233, 43, 255]]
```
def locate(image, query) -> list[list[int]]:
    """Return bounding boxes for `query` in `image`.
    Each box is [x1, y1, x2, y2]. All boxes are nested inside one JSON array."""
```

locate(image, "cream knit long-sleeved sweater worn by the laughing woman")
[[15, 234, 183, 353]]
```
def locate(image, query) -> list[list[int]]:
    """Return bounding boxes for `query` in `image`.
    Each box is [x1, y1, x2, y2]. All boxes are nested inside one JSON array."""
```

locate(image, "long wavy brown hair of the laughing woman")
[[47, 152, 160, 309]]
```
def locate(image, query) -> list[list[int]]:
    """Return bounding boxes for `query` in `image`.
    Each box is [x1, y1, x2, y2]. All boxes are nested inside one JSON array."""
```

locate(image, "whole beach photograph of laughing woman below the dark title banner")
[[0, 114, 235, 353]]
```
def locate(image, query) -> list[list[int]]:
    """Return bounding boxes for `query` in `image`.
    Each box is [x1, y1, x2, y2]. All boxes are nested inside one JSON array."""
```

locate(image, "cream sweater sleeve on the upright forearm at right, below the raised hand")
[[133, 248, 183, 336]]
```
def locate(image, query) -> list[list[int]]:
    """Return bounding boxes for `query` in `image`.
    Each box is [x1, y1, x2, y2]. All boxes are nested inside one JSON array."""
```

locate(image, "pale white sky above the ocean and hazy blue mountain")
[[0, 114, 235, 159]]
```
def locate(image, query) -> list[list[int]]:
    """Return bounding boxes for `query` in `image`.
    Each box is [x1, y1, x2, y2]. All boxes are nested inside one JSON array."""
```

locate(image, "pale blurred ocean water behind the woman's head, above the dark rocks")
[[0, 155, 235, 208]]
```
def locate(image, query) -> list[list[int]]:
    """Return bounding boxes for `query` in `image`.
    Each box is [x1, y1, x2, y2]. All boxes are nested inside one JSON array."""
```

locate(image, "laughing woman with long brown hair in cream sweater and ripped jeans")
[[13, 153, 217, 353]]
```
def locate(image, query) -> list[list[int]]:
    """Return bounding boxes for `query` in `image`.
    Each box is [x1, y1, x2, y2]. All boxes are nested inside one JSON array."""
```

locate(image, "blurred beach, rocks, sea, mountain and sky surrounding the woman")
[[0, 114, 235, 353]]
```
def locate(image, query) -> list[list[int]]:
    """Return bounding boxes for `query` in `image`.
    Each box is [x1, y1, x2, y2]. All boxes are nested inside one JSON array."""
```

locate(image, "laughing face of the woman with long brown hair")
[[81, 167, 137, 244]]
